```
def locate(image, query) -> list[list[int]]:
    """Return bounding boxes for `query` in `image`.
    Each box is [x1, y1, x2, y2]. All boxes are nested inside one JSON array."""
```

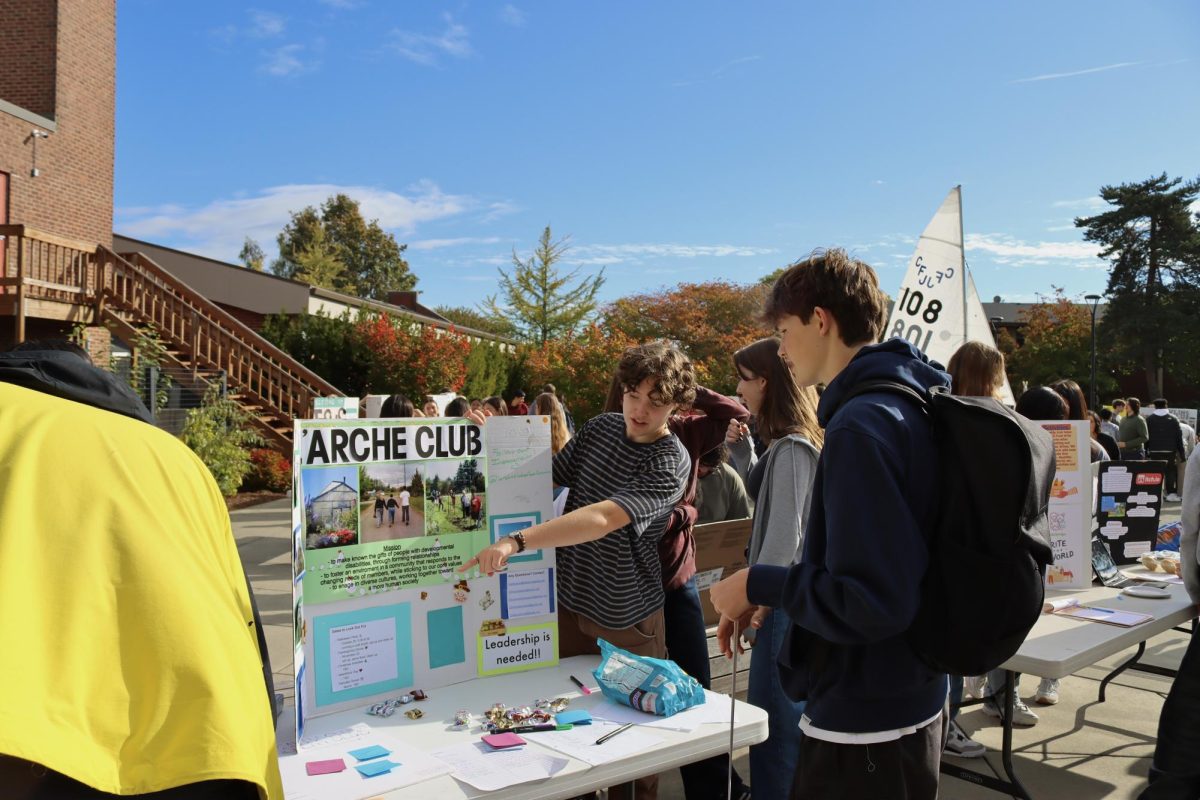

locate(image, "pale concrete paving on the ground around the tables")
[[230, 500, 1188, 800]]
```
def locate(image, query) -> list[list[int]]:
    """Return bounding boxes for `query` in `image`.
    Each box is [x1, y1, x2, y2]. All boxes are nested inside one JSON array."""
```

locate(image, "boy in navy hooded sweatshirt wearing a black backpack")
[[710, 249, 949, 799]]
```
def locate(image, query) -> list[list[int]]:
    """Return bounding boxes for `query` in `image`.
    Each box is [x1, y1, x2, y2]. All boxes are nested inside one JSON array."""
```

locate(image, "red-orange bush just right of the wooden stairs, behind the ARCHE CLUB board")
[[355, 314, 470, 405]]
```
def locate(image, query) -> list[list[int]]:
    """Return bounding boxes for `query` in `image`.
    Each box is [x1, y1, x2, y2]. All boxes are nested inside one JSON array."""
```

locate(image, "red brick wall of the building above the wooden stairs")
[[0, 0, 116, 246]]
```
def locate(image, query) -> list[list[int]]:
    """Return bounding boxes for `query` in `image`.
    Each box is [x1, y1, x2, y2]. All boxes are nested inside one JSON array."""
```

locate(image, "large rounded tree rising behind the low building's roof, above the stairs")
[[271, 194, 416, 300]]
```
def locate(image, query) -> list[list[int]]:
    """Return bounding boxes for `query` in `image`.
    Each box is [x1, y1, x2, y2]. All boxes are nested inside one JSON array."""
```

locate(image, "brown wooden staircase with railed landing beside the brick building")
[[0, 225, 342, 456]]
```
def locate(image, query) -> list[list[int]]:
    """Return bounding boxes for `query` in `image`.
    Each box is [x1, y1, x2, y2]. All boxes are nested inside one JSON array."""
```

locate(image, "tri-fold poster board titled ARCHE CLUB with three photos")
[[292, 416, 558, 741]]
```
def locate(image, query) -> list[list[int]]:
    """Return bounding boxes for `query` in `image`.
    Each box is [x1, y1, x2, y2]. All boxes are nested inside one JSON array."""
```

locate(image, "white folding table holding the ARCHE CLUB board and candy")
[[278, 656, 767, 800]]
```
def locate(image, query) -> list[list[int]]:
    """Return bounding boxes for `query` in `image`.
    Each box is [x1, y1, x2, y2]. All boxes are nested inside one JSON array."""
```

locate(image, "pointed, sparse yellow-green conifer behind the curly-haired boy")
[[480, 225, 605, 345]]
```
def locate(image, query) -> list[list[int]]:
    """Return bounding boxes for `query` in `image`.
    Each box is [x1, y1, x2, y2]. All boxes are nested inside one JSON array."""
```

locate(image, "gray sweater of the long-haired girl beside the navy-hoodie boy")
[[730, 434, 817, 566]]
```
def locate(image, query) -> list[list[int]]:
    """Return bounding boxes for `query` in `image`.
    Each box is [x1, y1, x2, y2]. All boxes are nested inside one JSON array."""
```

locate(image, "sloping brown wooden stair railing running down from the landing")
[[95, 246, 341, 434]]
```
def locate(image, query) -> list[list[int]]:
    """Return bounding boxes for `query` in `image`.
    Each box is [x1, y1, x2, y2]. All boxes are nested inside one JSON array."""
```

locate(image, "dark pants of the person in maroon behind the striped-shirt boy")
[[662, 578, 743, 800]]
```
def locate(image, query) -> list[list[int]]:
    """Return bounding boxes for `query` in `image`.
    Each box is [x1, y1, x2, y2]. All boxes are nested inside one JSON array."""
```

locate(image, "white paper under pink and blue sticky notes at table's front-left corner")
[[280, 726, 450, 800]]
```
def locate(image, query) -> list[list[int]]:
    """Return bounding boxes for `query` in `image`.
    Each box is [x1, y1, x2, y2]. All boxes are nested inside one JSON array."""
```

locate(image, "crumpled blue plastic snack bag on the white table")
[[592, 639, 704, 717]]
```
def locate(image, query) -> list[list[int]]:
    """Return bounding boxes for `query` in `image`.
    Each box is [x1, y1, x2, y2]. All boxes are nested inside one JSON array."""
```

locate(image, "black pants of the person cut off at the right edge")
[[1139, 628, 1200, 800]]
